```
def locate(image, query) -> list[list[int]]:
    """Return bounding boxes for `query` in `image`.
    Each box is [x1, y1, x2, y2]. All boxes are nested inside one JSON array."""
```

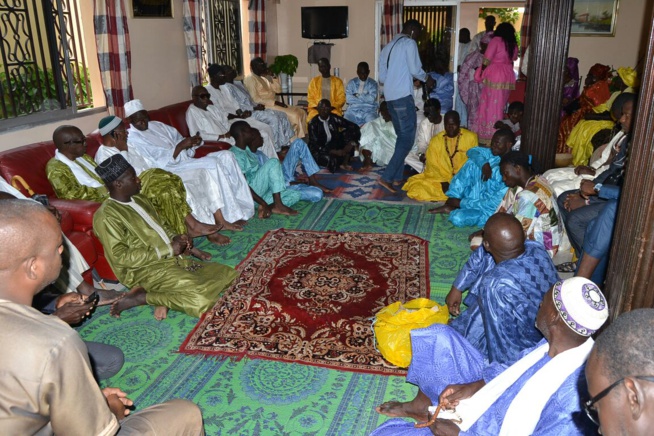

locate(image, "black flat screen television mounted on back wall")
[[302, 6, 349, 39]]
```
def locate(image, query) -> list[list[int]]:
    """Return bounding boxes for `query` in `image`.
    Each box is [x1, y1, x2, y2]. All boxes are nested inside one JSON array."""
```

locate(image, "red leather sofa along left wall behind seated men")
[[0, 102, 230, 281]]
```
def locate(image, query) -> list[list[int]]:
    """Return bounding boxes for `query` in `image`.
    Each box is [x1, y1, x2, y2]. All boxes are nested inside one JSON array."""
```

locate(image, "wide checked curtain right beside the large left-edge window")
[[93, 0, 134, 118]]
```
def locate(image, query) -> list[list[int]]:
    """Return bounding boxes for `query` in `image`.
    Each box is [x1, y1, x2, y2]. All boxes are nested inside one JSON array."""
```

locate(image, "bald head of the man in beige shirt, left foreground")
[[0, 200, 62, 304]]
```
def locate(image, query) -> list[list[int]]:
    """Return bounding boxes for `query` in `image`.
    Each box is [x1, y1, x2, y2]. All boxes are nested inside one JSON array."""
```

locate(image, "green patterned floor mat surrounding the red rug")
[[80, 199, 475, 435]]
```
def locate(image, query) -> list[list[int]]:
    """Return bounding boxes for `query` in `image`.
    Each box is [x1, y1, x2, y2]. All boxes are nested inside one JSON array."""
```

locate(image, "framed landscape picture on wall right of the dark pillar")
[[572, 0, 618, 36]]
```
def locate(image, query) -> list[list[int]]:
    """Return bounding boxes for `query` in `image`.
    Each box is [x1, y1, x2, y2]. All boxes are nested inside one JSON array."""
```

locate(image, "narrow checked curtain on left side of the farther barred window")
[[183, 0, 205, 87]]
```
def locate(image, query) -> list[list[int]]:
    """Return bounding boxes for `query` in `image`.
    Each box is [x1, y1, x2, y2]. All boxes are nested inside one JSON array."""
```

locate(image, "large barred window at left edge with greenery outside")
[[0, 0, 93, 129]]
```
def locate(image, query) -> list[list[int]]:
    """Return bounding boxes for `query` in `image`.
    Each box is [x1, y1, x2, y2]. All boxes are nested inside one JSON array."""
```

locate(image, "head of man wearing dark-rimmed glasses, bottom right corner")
[[584, 309, 654, 436]]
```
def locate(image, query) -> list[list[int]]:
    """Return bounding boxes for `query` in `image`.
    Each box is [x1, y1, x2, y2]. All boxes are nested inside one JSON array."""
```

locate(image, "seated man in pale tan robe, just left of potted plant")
[[243, 58, 307, 139]]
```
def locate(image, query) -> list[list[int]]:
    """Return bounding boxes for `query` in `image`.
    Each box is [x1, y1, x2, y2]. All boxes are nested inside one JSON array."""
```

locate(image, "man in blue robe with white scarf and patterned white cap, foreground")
[[372, 277, 608, 436]]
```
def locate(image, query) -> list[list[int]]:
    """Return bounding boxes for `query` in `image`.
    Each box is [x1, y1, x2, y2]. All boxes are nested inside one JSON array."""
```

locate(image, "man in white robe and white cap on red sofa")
[[125, 100, 254, 230]]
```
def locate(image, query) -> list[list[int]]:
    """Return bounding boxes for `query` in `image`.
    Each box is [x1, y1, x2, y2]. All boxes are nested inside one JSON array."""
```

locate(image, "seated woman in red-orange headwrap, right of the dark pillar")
[[556, 64, 611, 153]]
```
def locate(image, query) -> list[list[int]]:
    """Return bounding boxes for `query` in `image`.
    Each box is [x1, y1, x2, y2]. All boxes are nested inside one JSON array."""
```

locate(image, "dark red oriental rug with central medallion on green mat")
[[180, 229, 429, 375]]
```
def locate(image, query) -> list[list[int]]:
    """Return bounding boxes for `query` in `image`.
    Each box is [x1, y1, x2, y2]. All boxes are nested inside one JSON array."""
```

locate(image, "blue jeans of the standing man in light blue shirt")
[[382, 95, 417, 183]]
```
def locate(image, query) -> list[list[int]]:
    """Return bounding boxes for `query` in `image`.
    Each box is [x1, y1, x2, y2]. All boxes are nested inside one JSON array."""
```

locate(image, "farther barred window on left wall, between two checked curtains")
[[204, 0, 243, 74]]
